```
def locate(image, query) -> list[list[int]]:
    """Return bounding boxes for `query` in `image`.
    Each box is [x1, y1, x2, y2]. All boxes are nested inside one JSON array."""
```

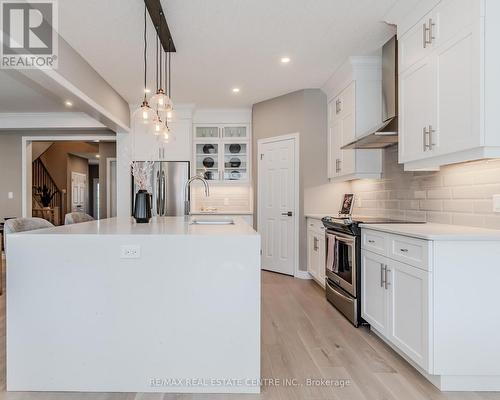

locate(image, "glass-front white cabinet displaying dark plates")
[[193, 124, 251, 183]]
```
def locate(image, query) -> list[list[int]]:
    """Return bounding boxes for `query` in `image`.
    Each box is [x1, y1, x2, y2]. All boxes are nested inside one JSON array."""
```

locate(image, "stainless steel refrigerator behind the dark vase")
[[132, 161, 189, 216]]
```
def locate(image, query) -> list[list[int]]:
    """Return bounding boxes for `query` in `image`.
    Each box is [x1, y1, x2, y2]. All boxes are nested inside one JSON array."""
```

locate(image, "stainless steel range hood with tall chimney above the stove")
[[342, 36, 398, 150]]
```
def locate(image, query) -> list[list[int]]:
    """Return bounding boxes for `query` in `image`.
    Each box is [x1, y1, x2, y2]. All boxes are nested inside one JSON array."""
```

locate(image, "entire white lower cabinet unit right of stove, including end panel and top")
[[361, 224, 500, 391]]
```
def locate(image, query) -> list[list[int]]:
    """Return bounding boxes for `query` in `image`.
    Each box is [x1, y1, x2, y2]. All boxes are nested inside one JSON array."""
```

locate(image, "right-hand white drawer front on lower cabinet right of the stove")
[[388, 236, 430, 270]]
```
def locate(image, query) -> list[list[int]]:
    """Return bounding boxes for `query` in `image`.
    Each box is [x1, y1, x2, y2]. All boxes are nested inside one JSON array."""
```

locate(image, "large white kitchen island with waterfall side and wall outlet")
[[7, 217, 260, 393]]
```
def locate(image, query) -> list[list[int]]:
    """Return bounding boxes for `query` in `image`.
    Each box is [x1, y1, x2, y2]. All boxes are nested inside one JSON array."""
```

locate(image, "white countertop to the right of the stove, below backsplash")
[[360, 223, 500, 241]]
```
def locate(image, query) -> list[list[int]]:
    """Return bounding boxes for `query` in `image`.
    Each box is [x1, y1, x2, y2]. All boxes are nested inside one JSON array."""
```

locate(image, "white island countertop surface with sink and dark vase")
[[12, 215, 258, 236]]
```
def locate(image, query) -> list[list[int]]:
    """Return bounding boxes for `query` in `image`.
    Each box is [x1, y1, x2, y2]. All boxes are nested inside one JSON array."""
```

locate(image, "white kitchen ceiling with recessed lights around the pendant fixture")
[[59, 0, 396, 107]]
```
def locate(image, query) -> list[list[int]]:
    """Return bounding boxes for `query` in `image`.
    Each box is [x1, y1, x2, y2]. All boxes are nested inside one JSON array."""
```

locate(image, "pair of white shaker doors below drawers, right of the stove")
[[361, 231, 432, 371]]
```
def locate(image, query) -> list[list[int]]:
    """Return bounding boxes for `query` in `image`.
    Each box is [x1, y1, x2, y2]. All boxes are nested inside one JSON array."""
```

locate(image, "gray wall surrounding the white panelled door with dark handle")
[[252, 89, 327, 270]]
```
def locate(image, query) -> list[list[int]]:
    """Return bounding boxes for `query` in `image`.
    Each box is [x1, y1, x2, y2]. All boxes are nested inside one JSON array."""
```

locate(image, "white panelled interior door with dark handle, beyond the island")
[[258, 136, 298, 275]]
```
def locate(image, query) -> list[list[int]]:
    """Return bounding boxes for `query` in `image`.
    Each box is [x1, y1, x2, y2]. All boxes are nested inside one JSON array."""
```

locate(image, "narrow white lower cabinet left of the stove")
[[307, 218, 326, 288]]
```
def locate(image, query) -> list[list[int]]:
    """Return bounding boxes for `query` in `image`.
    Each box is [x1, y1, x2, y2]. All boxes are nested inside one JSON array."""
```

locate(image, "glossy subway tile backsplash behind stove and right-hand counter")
[[351, 146, 500, 229]]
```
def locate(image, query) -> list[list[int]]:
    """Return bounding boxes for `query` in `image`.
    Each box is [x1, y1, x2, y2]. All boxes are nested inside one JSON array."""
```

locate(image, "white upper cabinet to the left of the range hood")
[[323, 57, 382, 181]]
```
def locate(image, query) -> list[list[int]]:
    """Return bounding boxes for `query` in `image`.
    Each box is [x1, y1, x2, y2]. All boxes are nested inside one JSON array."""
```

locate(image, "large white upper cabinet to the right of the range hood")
[[398, 0, 500, 170]]
